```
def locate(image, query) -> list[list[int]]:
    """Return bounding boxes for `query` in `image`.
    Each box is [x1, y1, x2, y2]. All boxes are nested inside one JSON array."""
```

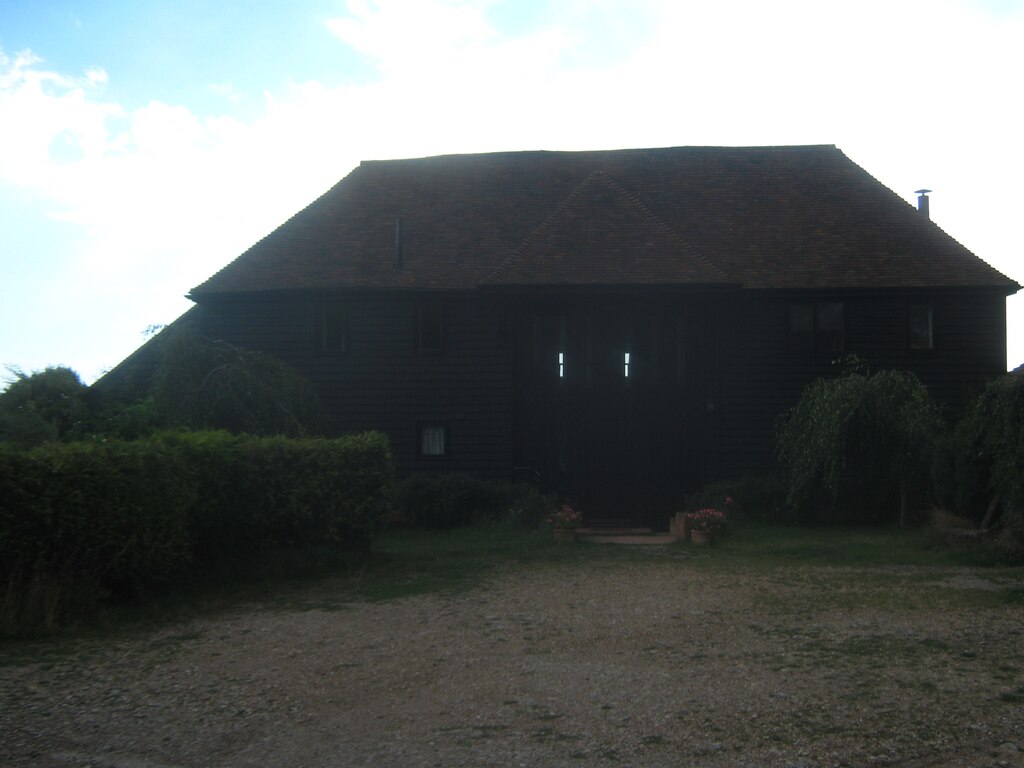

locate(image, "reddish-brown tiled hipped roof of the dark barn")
[[193, 145, 1019, 299]]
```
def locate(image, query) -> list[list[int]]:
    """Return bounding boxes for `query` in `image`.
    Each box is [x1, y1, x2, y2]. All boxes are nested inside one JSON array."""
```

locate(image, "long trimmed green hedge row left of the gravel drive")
[[0, 432, 393, 631]]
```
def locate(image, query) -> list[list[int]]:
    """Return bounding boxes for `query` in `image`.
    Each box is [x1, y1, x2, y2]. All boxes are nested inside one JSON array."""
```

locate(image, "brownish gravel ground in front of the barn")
[[0, 557, 1024, 768]]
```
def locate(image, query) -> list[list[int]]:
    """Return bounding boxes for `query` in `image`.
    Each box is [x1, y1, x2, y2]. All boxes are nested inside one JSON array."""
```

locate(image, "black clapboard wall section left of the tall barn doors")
[[204, 294, 512, 479]]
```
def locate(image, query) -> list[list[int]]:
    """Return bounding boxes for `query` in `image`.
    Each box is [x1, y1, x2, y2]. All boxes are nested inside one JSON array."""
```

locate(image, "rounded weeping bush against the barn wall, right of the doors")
[[778, 371, 942, 523]]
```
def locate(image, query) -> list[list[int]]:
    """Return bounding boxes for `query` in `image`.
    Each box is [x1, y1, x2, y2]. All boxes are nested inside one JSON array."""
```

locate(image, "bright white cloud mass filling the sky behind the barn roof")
[[0, 0, 1024, 376]]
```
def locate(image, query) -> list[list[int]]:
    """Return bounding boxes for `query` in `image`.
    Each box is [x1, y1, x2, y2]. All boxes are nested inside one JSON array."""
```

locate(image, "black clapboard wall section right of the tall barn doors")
[[710, 291, 1006, 479]]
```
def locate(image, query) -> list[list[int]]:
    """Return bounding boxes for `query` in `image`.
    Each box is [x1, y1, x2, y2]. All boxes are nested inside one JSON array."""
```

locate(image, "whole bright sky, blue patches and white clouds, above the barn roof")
[[0, 0, 1024, 383]]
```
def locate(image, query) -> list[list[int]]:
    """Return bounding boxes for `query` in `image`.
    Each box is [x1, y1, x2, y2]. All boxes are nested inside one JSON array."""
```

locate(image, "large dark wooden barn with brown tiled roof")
[[184, 146, 1019, 524]]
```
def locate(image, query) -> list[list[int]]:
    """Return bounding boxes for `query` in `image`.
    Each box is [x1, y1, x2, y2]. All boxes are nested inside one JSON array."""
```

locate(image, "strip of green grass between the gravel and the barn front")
[[0, 524, 1024, 666]]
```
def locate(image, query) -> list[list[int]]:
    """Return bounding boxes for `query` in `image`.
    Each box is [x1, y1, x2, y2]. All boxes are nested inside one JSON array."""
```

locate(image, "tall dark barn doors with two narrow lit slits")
[[516, 307, 687, 526]]
